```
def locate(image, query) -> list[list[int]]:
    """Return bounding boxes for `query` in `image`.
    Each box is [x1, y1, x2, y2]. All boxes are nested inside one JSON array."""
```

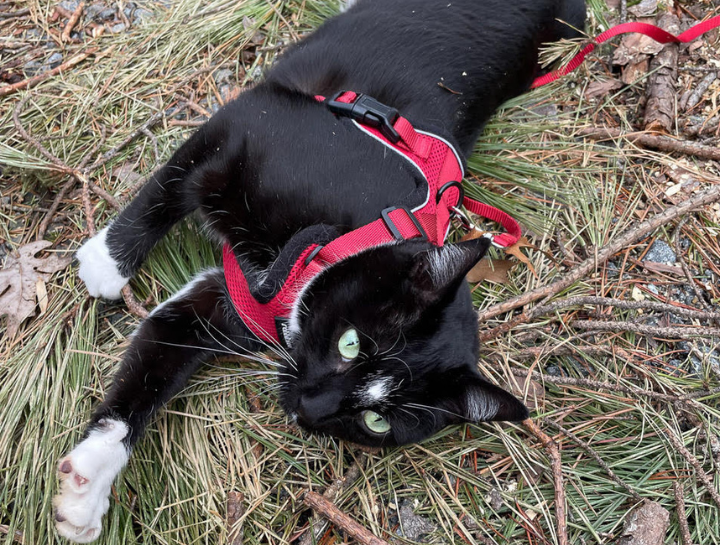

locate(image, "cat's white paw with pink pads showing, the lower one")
[[53, 420, 129, 543]]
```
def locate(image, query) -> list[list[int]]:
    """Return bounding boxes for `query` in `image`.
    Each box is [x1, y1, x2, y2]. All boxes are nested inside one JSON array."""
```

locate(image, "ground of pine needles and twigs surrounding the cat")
[[0, 0, 720, 545]]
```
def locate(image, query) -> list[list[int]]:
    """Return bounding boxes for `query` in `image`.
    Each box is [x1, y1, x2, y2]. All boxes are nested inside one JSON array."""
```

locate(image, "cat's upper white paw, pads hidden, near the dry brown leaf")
[[76, 227, 130, 299]]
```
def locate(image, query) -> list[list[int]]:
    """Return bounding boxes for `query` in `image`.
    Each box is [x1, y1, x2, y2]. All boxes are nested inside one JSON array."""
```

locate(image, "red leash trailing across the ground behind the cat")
[[531, 15, 720, 89]]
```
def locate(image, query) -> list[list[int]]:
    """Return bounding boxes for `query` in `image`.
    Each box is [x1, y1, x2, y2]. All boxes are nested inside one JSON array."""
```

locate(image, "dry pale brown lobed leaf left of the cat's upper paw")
[[0, 240, 72, 338]]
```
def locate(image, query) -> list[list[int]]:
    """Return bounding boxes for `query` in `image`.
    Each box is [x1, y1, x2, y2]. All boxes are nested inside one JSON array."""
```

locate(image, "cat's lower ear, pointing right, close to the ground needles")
[[442, 371, 529, 422]]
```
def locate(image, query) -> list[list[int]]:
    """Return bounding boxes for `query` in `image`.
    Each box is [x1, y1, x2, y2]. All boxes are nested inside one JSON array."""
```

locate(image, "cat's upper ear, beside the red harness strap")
[[409, 237, 490, 302]]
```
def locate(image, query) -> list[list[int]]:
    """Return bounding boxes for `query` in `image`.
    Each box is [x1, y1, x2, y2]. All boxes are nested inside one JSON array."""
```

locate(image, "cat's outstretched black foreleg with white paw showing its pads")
[[53, 268, 261, 543]]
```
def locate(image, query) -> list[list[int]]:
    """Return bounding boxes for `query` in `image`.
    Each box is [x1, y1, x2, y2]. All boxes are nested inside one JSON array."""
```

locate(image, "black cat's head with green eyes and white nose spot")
[[280, 238, 528, 446]]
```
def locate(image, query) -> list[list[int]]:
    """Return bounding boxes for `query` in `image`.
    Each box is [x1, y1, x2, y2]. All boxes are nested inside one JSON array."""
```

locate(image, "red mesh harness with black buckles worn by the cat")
[[223, 92, 520, 345]]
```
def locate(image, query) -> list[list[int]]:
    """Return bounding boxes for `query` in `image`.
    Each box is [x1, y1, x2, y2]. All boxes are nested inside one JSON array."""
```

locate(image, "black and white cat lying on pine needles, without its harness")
[[54, 0, 585, 542]]
